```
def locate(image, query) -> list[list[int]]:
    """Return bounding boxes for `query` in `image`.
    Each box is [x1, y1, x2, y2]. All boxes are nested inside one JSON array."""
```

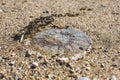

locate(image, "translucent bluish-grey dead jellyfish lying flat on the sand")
[[31, 29, 91, 59]]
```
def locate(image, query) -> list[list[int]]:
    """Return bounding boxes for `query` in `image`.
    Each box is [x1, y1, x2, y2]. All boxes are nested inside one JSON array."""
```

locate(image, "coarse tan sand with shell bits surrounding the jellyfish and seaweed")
[[0, 0, 120, 80]]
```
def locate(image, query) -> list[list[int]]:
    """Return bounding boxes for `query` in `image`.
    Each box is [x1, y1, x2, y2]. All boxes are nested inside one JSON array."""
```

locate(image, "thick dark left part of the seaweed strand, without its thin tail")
[[13, 16, 54, 42]]
